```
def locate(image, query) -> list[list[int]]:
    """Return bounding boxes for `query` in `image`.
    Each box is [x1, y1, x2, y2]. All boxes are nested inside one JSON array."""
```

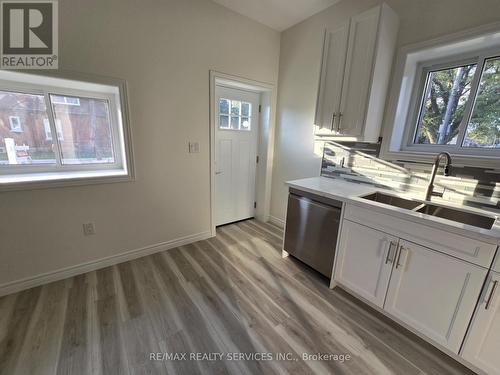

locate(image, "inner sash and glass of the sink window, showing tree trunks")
[[406, 55, 500, 155]]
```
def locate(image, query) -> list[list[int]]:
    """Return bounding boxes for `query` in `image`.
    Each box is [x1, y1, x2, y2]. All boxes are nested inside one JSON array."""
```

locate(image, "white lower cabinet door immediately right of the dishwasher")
[[335, 220, 398, 307]]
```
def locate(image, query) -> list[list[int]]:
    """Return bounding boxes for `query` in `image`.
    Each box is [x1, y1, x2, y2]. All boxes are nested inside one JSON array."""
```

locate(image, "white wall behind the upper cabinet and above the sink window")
[[271, 0, 500, 219]]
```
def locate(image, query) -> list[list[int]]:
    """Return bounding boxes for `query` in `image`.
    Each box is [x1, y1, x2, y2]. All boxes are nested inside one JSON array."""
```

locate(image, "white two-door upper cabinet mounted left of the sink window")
[[315, 4, 399, 142]]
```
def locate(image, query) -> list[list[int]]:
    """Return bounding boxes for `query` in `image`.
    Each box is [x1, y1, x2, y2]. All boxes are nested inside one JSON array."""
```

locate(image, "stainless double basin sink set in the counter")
[[361, 192, 496, 229]]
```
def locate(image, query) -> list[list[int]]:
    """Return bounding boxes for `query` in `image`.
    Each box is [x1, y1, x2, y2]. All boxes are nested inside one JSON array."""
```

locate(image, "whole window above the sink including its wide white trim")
[[381, 21, 500, 167]]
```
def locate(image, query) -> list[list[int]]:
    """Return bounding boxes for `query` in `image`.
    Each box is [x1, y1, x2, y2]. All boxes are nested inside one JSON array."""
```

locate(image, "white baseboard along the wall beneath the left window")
[[0, 231, 212, 297]]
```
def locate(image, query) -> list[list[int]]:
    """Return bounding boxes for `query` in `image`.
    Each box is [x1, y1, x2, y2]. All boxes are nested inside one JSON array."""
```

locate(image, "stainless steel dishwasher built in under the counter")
[[283, 189, 342, 278]]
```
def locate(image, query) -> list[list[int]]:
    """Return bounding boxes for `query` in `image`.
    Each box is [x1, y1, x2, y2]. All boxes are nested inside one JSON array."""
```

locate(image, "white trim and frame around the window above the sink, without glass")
[[380, 22, 500, 168]]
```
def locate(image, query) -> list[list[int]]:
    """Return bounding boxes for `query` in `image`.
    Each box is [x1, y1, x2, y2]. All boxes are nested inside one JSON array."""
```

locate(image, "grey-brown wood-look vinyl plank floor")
[[0, 220, 470, 375]]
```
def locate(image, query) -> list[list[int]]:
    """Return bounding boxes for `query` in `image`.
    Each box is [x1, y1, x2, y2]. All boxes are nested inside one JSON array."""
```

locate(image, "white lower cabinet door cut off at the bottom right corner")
[[462, 272, 500, 375]]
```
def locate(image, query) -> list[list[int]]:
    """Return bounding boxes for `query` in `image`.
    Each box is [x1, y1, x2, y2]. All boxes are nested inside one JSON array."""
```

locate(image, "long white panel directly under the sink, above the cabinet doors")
[[345, 204, 498, 268]]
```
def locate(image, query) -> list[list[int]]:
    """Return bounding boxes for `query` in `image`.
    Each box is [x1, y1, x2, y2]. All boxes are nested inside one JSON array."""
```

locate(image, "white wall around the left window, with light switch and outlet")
[[0, 0, 280, 286]]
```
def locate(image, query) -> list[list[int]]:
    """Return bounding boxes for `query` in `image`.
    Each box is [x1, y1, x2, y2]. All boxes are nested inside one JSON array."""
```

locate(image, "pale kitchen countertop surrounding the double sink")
[[286, 177, 500, 245]]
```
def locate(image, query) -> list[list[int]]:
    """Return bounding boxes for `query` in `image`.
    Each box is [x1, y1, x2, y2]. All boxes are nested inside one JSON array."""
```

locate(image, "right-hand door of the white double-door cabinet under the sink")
[[384, 240, 487, 354]]
